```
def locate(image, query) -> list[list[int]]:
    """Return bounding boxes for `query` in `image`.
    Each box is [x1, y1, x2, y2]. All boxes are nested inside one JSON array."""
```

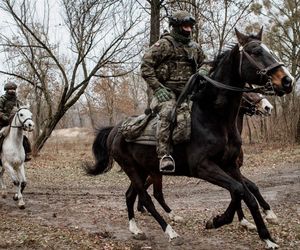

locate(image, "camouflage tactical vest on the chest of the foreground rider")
[[155, 35, 198, 94]]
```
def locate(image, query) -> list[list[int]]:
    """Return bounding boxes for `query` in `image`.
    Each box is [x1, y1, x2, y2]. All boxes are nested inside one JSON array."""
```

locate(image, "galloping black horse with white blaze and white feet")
[[86, 30, 293, 248]]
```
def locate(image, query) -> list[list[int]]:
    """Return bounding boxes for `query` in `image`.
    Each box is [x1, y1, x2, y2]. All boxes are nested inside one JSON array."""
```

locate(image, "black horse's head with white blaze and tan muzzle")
[[235, 29, 294, 96]]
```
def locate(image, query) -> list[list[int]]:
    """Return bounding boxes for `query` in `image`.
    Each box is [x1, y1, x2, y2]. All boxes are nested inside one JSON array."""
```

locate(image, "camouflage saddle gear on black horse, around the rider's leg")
[[119, 102, 192, 146]]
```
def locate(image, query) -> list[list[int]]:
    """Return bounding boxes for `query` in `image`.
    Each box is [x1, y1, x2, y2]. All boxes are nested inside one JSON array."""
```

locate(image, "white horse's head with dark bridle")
[[11, 106, 34, 132]]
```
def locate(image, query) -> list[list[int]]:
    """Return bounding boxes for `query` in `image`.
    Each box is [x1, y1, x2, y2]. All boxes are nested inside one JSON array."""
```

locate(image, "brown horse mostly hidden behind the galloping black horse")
[[137, 92, 278, 230]]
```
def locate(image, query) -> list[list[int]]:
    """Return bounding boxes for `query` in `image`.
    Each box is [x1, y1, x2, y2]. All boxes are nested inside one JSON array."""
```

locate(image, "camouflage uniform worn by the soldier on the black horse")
[[141, 11, 204, 171]]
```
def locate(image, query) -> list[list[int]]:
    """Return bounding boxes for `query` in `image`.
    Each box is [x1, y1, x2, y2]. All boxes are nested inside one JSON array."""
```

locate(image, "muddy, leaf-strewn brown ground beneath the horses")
[[0, 137, 300, 250]]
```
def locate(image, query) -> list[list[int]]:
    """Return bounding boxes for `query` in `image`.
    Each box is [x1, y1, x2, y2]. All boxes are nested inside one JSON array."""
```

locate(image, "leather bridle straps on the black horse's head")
[[238, 40, 284, 89]]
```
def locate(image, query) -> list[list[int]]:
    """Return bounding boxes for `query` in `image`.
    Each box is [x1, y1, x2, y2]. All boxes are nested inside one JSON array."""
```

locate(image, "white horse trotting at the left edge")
[[0, 106, 34, 209]]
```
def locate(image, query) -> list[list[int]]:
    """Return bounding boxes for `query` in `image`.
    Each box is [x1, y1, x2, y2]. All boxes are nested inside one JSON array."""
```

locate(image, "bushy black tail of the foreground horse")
[[83, 127, 114, 175]]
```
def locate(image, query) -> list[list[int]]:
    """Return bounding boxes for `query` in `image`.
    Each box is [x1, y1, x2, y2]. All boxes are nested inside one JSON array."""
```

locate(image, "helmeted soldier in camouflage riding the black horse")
[[141, 11, 205, 172]]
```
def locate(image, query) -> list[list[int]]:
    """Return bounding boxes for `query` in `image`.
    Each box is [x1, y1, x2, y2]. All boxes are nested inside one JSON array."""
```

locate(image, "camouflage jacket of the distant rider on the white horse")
[[0, 94, 22, 127]]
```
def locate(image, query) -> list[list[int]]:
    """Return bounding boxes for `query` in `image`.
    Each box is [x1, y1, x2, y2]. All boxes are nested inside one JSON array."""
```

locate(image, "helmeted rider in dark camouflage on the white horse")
[[0, 82, 31, 161]]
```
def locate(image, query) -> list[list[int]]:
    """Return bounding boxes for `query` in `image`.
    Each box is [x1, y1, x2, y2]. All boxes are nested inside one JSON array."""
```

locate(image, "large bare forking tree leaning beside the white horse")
[[0, 0, 143, 153]]
